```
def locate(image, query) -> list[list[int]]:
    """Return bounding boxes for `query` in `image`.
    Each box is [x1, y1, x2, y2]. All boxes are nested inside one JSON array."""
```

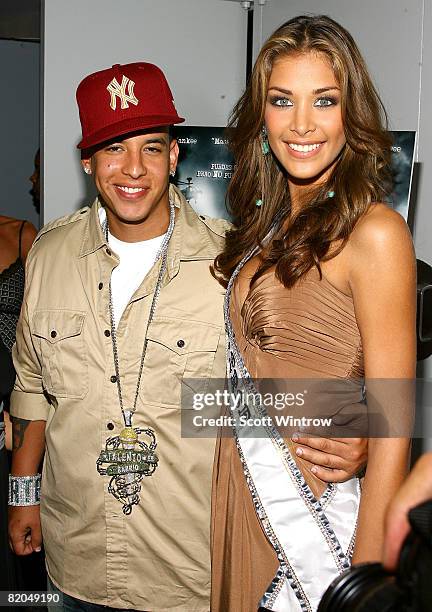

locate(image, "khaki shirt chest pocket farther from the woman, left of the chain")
[[32, 310, 88, 399]]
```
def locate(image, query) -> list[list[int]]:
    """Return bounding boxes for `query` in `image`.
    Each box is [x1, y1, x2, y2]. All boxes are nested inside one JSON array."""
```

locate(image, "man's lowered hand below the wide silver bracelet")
[[9, 506, 42, 556]]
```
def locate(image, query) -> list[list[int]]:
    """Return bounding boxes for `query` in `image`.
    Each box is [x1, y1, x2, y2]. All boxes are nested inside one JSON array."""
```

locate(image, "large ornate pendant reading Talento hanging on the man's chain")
[[96, 420, 158, 514]]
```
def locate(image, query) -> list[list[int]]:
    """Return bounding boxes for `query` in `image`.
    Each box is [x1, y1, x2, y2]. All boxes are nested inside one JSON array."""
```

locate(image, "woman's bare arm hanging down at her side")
[[347, 204, 416, 563]]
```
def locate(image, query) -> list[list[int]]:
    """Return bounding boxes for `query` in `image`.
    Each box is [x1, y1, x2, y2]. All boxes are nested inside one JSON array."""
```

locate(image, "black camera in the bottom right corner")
[[317, 500, 432, 612]]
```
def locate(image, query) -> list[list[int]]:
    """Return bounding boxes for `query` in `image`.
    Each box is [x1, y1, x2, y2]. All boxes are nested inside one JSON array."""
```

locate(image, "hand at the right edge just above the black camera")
[[383, 453, 432, 570]]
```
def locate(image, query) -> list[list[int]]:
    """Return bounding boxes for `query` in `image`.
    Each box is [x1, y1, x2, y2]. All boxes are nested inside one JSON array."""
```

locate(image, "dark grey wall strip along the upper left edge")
[[0, 40, 40, 227]]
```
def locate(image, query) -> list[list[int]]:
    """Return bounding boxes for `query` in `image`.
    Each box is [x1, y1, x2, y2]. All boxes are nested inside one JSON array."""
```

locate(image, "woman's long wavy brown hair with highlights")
[[214, 15, 391, 287]]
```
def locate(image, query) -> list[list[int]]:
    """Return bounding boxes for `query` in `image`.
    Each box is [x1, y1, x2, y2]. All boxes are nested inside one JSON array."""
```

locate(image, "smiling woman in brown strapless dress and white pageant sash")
[[212, 16, 415, 612]]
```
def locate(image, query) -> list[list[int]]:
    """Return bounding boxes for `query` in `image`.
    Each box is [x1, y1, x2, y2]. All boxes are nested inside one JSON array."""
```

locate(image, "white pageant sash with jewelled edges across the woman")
[[225, 241, 360, 612]]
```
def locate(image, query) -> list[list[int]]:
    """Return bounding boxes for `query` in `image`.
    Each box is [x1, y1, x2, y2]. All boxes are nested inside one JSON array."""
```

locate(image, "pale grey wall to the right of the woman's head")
[[253, 0, 432, 450]]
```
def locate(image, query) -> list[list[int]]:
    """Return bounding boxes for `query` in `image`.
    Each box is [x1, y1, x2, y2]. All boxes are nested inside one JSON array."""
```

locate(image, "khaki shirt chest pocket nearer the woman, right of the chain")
[[140, 317, 221, 408]]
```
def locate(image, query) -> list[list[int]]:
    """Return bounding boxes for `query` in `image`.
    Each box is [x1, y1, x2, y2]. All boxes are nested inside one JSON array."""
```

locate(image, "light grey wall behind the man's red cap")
[[43, 0, 247, 222]]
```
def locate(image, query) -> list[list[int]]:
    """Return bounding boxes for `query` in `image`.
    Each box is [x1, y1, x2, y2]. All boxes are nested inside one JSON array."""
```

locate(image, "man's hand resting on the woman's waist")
[[292, 434, 367, 482]]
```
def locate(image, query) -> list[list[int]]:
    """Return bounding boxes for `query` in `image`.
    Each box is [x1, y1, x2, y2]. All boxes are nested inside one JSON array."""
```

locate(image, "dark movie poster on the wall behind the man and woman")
[[173, 126, 415, 219]]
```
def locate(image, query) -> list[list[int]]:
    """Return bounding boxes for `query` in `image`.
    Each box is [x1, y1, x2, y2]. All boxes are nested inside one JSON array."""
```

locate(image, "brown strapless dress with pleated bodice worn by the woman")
[[211, 257, 363, 612]]
